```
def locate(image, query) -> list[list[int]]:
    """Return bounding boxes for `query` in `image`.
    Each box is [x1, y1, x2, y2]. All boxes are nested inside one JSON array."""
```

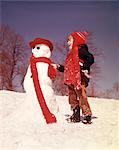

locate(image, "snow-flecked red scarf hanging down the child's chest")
[[64, 46, 80, 87]]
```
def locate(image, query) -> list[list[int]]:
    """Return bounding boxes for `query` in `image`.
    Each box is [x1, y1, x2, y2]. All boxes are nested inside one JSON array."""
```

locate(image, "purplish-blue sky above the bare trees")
[[1, 0, 119, 92]]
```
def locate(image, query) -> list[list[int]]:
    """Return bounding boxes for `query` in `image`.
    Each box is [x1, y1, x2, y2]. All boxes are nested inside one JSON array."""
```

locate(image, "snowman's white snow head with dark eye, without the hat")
[[32, 44, 51, 58]]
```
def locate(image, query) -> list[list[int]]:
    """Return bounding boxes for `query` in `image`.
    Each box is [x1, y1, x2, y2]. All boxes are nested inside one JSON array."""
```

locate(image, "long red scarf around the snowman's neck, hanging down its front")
[[30, 55, 56, 124]]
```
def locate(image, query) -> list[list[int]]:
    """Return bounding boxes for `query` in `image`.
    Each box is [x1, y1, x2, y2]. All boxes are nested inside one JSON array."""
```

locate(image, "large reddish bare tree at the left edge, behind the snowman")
[[0, 25, 28, 91]]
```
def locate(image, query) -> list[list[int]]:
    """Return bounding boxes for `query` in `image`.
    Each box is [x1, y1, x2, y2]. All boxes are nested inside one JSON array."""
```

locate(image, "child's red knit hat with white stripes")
[[70, 31, 89, 45]]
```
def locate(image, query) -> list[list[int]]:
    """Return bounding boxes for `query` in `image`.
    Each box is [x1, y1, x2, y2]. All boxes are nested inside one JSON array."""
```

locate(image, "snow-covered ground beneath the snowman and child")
[[0, 91, 119, 150]]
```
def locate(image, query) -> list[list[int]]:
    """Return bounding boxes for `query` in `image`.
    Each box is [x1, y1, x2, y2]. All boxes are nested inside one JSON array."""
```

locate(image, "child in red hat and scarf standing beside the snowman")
[[57, 32, 94, 124]]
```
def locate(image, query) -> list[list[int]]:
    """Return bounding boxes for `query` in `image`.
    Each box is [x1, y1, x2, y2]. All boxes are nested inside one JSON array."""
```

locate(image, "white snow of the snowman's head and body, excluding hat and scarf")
[[24, 44, 58, 122]]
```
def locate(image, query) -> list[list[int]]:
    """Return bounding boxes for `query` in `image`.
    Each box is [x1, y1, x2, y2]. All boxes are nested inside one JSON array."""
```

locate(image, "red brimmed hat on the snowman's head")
[[29, 38, 53, 51]]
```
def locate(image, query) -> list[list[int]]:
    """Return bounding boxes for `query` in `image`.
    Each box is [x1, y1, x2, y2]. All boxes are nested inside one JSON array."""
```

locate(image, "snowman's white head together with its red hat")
[[29, 38, 53, 58]]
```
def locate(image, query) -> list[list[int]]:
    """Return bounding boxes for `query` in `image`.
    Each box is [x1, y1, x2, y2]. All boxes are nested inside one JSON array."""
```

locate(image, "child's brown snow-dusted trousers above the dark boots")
[[68, 84, 92, 116]]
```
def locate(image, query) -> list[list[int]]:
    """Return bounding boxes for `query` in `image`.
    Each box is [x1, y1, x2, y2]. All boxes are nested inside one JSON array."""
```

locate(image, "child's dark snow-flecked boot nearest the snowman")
[[67, 106, 80, 123]]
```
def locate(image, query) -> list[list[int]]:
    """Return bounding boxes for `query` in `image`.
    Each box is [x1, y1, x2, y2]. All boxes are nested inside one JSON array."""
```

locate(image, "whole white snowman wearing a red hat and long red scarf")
[[24, 38, 59, 124]]
